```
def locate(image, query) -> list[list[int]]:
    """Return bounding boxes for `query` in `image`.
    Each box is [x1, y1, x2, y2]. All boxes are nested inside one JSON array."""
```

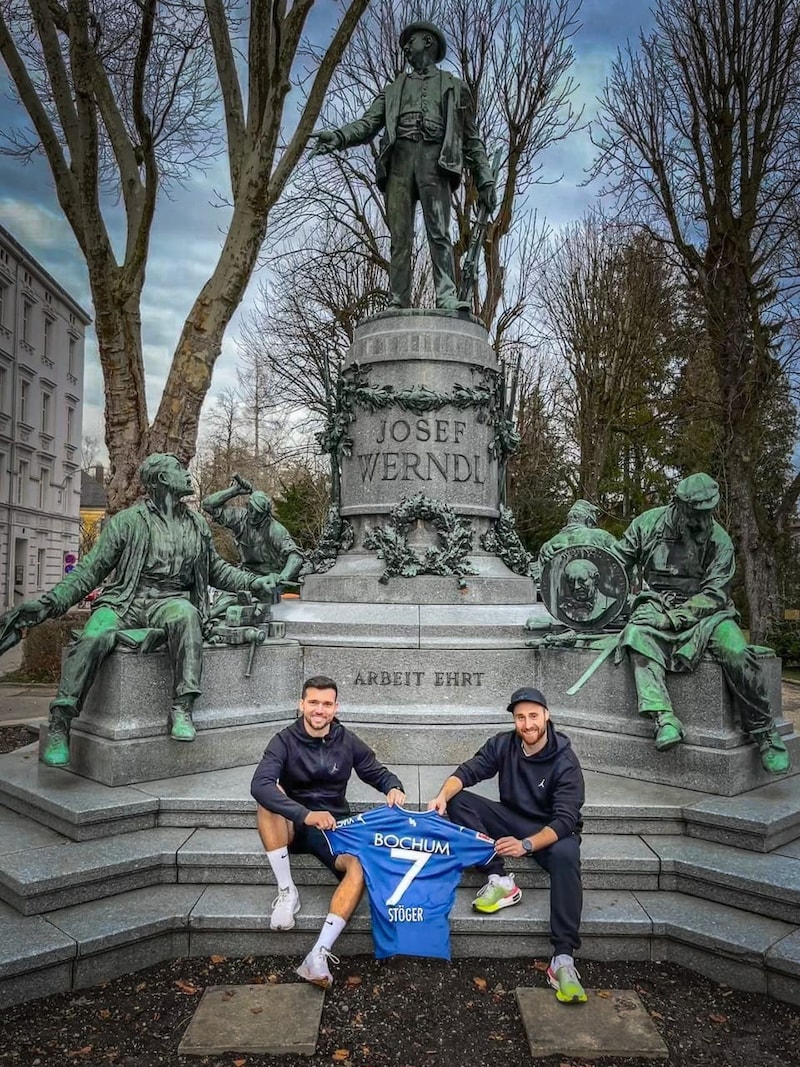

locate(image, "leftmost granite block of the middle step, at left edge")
[[0, 829, 190, 914]]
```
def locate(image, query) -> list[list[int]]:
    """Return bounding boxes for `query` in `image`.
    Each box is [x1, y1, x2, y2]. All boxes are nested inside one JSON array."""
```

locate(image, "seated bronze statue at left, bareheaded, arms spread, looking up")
[[0, 452, 272, 767]]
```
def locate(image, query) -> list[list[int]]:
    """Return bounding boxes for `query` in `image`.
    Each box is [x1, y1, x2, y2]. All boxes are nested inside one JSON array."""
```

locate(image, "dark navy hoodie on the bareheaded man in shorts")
[[250, 716, 404, 823]]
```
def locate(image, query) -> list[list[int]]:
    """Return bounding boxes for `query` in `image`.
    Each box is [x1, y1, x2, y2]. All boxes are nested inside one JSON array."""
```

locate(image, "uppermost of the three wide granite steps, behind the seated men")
[[0, 746, 800, 851]]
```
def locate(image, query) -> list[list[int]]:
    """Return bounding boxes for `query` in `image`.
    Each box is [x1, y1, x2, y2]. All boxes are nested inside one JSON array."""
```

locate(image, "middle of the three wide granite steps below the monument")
[[0, 815, 800, 924]]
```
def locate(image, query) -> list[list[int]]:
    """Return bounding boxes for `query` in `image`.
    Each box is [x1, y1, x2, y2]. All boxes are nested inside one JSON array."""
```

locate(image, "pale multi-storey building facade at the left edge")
[[0, 226, 91, 611]]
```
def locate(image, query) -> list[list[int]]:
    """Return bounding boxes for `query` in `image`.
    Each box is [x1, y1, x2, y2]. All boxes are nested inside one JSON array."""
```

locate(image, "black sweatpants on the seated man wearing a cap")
[[447, 790, 583, 956]]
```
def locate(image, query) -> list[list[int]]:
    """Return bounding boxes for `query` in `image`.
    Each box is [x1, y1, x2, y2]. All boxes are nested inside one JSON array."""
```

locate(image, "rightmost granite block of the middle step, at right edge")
[[644, 835, 800, 924]]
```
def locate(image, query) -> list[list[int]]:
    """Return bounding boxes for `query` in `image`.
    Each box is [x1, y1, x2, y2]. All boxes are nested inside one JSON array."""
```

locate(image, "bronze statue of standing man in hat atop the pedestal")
[[315, 22, 496, 310]]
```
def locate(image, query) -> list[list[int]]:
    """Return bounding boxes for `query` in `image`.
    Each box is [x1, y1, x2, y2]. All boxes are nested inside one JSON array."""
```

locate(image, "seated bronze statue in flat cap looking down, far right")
[[614, 474, 790, 775]]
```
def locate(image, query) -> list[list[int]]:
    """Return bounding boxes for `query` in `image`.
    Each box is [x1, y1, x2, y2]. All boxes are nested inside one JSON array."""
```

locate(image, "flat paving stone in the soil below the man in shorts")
[[178, 982, 325, 1056]]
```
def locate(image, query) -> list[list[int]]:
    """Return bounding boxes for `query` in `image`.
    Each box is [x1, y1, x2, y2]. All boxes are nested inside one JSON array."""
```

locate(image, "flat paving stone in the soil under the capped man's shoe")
[[516, 988, 668, 1060]]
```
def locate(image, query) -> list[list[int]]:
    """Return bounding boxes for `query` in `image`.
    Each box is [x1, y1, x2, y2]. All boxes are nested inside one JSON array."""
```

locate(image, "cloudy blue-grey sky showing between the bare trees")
[[0, 0, 651, 450]]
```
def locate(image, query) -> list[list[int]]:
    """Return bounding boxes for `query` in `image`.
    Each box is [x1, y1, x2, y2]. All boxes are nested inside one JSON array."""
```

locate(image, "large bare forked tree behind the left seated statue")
[[0, 0, 368, 510]]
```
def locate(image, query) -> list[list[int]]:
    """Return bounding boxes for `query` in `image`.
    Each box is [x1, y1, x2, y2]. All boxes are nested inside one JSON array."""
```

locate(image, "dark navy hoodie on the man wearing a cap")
[[453, 722, 585, 838]]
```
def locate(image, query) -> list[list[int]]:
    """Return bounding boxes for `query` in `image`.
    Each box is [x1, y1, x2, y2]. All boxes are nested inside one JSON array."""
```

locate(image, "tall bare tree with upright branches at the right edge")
[[595, 0, 800, 640]]
